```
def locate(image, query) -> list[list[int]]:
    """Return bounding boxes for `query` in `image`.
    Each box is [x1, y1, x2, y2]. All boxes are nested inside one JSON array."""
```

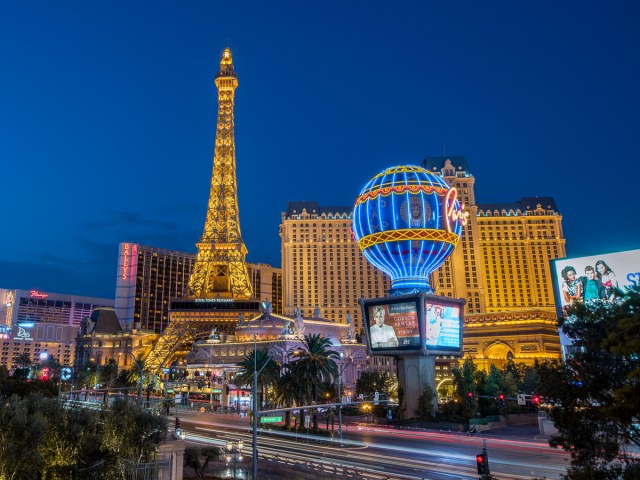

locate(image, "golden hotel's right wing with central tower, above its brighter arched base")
[[422, 157, 566, 314]]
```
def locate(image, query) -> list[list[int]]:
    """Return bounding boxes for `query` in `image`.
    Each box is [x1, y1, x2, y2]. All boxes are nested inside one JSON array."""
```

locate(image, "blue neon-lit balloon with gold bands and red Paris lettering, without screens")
[[353, 166, 469, 293]]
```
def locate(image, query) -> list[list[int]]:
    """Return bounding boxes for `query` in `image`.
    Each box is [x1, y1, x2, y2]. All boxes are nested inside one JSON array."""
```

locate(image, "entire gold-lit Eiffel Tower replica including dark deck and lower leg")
[[145, 47, 260, 373]]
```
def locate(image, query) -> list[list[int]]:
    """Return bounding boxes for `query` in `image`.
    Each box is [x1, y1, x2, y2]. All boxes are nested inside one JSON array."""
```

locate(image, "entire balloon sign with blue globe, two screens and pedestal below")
[[353, 165, 469, 416]]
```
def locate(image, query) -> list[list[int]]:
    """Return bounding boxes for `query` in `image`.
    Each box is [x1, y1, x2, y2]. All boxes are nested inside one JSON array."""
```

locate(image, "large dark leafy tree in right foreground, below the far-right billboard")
[[539, 288, 640, 479]]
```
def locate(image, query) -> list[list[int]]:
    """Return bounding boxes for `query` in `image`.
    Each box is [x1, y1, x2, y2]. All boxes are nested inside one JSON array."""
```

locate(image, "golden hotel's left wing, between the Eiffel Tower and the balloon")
[[280, 202, 391, 329]]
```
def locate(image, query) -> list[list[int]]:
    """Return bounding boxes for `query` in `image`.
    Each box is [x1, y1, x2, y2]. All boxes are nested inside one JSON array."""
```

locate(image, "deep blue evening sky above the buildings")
[[0, 1, 640, 297]]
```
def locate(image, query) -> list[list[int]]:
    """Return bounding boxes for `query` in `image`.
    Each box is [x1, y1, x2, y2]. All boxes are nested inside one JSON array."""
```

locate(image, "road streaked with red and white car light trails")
[[172, 411, 569, 480]]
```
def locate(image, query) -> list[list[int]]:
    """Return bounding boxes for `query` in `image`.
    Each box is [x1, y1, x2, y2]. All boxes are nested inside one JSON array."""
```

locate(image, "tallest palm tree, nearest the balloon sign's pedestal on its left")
[[292, 334, 340, 431]]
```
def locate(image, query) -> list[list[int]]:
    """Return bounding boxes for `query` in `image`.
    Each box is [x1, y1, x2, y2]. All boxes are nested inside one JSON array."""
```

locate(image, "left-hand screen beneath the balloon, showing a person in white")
[[366, 300, 421, 353]]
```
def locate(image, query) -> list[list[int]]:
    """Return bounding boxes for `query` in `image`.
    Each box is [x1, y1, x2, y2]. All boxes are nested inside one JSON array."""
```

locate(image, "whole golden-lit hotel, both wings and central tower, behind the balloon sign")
[[280, 157, 566, 382]]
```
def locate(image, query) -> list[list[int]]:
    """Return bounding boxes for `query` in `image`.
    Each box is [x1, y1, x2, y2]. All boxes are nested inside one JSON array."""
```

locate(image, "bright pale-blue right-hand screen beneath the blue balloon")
[[424, 298, 461, 351]]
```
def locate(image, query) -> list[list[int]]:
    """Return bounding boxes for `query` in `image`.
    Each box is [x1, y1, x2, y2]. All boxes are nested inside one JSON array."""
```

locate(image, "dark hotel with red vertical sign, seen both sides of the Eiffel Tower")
[[115, 242, 282, 333]]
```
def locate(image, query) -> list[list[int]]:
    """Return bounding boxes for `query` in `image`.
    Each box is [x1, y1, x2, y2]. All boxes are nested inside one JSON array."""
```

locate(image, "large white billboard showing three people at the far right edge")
[[551, 250, 640, 317]]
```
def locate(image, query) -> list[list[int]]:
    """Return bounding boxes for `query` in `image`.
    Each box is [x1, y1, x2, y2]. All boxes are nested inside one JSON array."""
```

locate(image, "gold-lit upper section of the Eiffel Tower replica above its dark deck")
[[187, 46, 253, 299]]
